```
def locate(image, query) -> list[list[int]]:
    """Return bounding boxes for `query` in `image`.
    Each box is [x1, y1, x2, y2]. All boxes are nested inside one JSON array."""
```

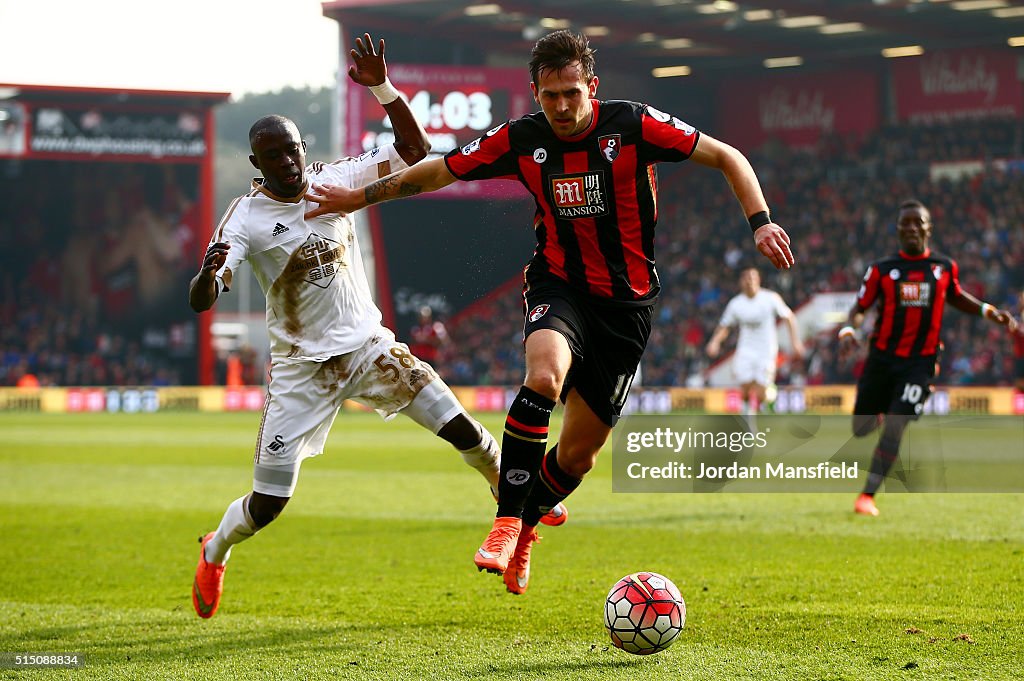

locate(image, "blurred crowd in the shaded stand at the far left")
[[0, 162, 200, 386]]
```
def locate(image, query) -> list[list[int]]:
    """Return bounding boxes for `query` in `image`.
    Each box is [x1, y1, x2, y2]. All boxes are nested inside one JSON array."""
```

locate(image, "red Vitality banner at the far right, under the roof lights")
[[891, 50, 1022, 124]]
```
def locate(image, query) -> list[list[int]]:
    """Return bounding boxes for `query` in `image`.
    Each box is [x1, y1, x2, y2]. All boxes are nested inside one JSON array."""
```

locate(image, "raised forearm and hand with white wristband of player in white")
[[348, 33, 430, 166]]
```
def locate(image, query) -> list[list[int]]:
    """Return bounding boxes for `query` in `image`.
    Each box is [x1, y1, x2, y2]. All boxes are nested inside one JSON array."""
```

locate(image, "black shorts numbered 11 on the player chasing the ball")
[[523, 281, 652, 426]]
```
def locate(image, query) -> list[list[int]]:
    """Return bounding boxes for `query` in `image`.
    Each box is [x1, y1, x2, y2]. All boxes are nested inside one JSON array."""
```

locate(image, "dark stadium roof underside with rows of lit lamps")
[[323, 0, 1024, 75]]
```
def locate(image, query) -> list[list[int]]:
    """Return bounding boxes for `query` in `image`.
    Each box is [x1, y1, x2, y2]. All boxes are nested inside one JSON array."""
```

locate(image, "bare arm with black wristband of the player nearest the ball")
[[690, 133, 796, 269]]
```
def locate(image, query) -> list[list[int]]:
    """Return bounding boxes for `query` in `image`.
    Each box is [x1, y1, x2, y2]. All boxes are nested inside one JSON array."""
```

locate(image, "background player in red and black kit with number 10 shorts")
[[839, 200, 1017, 515]]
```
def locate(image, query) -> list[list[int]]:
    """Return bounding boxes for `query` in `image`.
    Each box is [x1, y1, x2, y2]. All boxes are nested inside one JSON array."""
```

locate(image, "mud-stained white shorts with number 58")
[[253, 327, 463, 497]]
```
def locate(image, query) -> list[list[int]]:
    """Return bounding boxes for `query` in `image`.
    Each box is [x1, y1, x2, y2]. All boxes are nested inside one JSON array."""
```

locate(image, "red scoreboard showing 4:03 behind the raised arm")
[[344, 65, 535, 199]]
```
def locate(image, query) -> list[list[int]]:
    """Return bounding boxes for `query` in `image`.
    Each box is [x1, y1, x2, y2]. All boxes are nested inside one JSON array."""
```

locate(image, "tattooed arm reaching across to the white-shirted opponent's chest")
[[306, 158, 456, 220]]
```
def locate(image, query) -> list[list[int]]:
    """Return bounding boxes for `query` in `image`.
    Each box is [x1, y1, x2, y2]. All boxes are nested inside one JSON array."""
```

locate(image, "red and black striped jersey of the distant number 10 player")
[[857, 250, 962, 357]]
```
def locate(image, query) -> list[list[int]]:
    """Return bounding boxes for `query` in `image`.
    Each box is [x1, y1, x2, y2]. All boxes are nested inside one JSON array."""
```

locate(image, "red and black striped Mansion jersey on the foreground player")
[[444, 99, 699, 305]]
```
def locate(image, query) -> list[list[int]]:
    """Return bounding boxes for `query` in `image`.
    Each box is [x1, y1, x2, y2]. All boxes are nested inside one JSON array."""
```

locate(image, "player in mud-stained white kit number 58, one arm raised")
[[189, 35, 565, 618]]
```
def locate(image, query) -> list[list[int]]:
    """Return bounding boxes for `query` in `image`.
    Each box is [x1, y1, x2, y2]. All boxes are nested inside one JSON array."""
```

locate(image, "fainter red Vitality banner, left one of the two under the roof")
[[709, 72, 881, 150]]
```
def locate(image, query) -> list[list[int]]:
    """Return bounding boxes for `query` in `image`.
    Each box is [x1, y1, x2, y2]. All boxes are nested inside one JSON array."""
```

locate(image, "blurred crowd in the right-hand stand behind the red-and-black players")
[[438, 120, 1024, 387]]
